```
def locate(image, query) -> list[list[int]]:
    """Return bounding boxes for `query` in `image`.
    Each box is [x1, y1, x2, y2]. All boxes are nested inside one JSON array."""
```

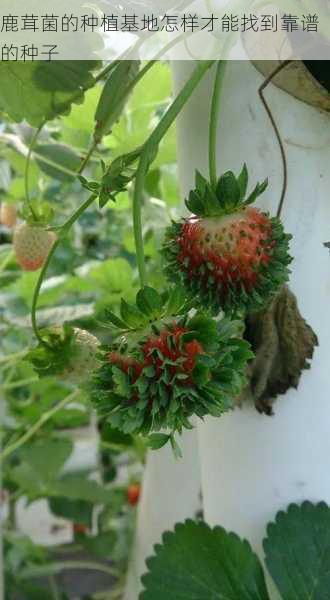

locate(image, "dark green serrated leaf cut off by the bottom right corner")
[[264, 502, 330, 600]]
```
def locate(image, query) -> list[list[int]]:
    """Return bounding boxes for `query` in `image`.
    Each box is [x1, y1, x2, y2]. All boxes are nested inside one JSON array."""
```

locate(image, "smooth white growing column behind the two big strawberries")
[[125, 61, 330, 600]]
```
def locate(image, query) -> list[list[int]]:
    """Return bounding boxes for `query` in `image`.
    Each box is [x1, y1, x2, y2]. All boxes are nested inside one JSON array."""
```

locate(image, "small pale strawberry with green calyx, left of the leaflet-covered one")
[[27, 325, 99, 385]]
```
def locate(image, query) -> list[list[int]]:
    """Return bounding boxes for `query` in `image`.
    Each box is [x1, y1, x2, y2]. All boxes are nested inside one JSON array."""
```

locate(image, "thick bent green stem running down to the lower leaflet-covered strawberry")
[[133, 60, 214, 287]]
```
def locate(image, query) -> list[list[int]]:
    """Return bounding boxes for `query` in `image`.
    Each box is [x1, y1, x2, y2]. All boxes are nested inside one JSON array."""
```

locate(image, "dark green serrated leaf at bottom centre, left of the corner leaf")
[[140, 521, 269, 600]]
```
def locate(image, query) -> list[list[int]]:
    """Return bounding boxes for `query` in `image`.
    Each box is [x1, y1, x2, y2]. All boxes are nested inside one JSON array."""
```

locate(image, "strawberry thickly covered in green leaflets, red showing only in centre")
[[91, 287, 253, 441]]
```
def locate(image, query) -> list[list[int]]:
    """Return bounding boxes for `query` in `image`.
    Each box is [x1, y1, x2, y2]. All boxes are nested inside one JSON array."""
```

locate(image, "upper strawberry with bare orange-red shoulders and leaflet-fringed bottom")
[[163, 165, 291, 313]]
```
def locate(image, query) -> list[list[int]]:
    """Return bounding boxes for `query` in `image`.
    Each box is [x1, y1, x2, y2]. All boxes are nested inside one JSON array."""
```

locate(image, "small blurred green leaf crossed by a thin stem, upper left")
[[36, 144, 81, 181]]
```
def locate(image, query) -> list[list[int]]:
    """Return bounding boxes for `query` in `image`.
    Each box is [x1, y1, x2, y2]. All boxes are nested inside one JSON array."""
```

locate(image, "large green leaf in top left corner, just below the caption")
[[0, 60, 99, 127]]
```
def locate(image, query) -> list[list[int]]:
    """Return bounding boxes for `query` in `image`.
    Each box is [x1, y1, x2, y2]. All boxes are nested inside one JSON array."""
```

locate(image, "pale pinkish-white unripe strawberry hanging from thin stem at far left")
[[13, 223, 56, 271]]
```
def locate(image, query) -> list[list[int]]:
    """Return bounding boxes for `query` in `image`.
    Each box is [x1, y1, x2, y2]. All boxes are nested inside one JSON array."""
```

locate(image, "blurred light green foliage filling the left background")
[[0, 62, 178, 599]]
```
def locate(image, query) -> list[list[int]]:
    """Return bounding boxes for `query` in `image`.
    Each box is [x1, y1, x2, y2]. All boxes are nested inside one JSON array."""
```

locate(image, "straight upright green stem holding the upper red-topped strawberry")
[[209, 60, 226, 188]]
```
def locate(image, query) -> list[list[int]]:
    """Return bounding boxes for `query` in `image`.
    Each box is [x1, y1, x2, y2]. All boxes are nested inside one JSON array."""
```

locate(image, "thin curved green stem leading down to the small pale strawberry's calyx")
[[31, 194, 96, 346]]
